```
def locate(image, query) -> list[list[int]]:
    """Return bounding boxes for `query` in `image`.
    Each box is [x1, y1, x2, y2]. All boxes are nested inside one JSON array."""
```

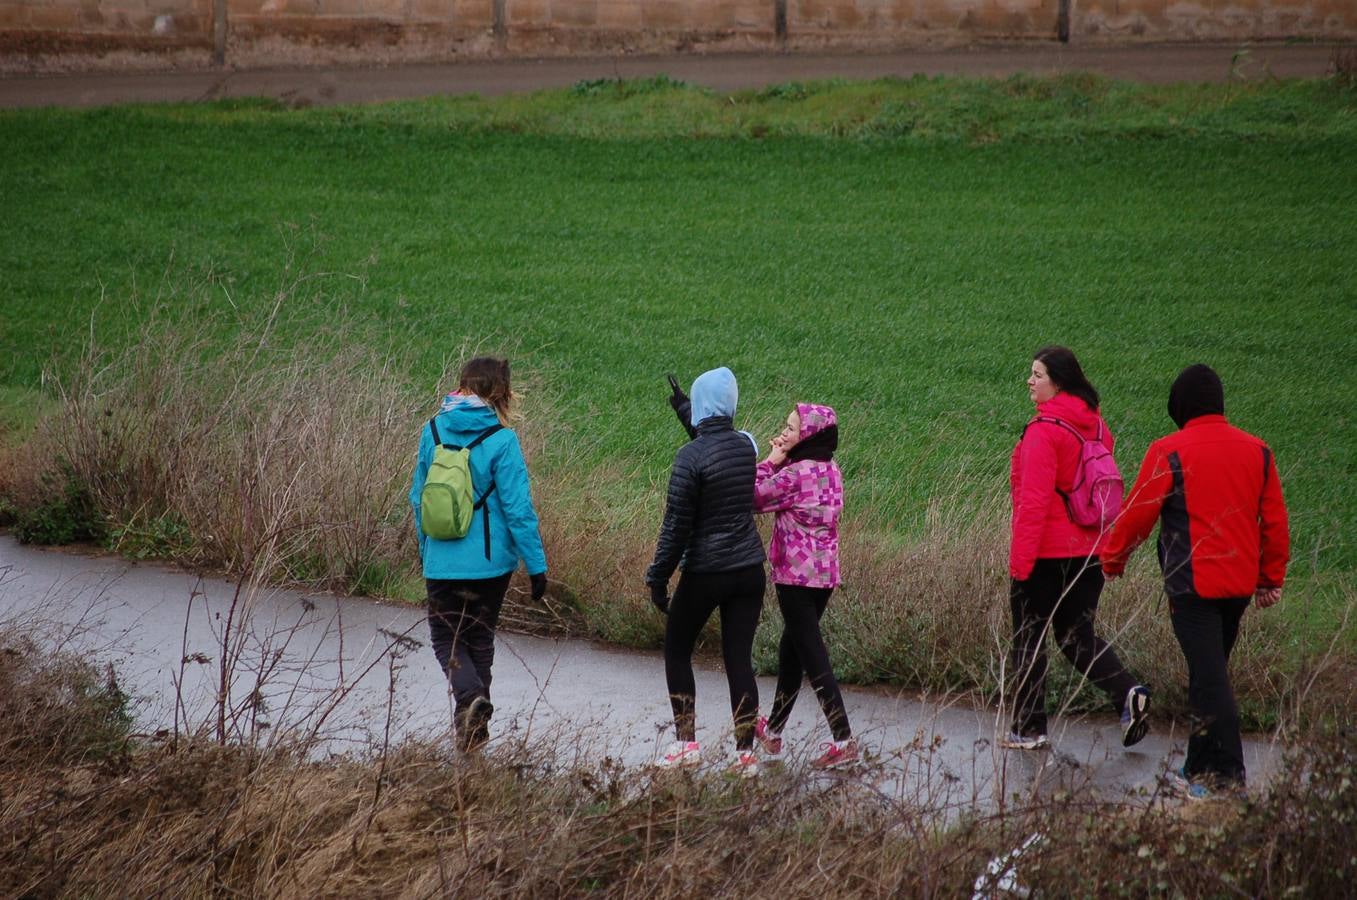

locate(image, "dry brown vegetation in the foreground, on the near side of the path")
[[0, 631, 1357, 897]]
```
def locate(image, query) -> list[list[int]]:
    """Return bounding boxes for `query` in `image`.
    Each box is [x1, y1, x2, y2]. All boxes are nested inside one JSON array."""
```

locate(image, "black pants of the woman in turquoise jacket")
[[425, 573, 513, 713]]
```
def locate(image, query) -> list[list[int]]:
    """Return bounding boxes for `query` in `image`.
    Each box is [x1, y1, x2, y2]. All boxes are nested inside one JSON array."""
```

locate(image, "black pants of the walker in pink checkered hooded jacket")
[[768, 584, 852, 741]]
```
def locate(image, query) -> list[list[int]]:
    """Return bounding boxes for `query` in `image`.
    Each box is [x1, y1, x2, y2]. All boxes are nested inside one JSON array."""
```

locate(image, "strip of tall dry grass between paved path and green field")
[[0, 271, 1357, 725]]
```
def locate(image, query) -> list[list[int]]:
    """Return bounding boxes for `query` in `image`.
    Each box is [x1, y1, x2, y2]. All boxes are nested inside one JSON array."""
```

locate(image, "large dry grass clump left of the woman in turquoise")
[[14, 278, 445, 590]]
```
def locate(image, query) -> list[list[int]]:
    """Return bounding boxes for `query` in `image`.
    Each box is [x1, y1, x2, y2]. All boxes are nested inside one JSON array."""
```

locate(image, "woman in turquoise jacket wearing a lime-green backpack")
[[410, 357, 547, 751]]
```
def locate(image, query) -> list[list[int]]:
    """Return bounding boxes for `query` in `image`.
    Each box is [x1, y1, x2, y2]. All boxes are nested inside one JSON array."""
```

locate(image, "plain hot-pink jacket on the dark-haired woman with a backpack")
[[1008, 394, 1114, 581]]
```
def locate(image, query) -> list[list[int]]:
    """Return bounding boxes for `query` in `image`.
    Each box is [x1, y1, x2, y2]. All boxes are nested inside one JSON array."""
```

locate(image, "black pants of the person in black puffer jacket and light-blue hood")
[[665, 565, 764, 749]]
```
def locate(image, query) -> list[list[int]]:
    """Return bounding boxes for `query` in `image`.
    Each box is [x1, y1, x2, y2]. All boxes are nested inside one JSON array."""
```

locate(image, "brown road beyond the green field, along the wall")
[[0, 42, 1334, 109]]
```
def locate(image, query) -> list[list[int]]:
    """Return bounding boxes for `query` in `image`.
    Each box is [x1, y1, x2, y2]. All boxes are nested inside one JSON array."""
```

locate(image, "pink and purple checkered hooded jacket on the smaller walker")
[[754, 403, 844, 588]]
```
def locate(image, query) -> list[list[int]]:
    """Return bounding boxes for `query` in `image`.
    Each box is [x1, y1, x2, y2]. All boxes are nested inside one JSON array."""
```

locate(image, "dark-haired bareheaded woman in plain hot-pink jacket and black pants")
[[999, 346, 1149, 749]]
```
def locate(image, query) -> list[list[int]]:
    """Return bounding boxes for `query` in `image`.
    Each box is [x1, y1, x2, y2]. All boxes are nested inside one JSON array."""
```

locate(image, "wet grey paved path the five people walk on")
[[0, 535, 1278, 809]]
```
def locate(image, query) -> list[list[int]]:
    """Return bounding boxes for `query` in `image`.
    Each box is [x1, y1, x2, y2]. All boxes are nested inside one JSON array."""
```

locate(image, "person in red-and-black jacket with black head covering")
[[1103, 364, 1291, 798]]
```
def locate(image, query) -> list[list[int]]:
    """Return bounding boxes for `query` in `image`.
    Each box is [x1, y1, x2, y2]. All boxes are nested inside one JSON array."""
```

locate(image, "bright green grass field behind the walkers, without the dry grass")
[[0, 77, 1357, 571]]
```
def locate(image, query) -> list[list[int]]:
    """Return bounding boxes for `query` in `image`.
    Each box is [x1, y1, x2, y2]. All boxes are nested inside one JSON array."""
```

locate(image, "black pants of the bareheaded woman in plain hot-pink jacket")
[[1008, 557, 1136, 734]]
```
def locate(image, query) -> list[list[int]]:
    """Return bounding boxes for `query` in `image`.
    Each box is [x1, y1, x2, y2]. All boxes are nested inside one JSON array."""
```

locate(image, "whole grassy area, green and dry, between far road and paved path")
[[0, 76, 1357, 722]]
